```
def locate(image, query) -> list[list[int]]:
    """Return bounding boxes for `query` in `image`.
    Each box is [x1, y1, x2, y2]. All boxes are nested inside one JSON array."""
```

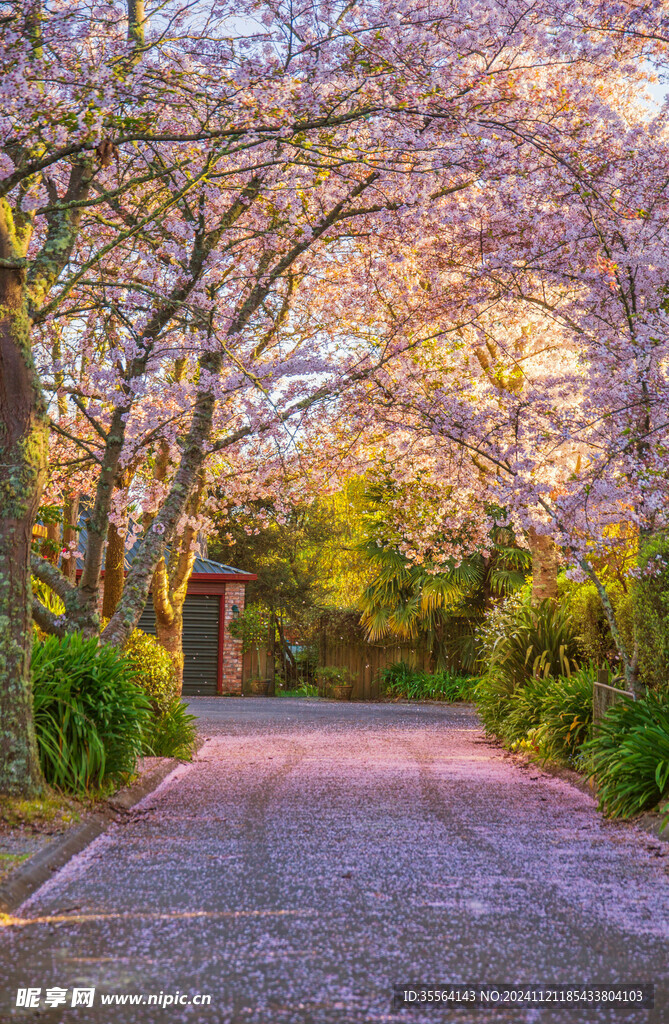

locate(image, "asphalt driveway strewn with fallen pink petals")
[[0, 697, 669, 1024]]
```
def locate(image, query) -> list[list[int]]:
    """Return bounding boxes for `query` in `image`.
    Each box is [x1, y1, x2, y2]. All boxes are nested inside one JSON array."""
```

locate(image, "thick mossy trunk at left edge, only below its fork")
[[0, 258, 48, 798]]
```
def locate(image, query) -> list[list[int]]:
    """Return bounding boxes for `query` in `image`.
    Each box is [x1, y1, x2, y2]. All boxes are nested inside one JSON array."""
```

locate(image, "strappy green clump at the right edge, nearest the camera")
[[584, 692, 669, 818]]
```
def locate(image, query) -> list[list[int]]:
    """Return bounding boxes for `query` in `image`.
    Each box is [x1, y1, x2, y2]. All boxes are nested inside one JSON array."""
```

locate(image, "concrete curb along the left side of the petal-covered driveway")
[[0, 757, 180, 913]]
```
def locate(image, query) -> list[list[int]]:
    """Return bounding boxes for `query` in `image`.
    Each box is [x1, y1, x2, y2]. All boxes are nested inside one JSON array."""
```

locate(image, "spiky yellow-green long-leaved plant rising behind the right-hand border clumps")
[[482, 601, 582, 686]]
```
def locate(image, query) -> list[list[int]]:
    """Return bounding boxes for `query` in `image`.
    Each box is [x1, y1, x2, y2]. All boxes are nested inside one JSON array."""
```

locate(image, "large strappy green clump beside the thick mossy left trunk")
[[33, 633, 151, 793]]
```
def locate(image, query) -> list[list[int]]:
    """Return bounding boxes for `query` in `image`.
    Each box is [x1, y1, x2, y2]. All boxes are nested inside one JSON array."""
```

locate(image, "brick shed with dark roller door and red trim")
[[77, 522, 257, 696]]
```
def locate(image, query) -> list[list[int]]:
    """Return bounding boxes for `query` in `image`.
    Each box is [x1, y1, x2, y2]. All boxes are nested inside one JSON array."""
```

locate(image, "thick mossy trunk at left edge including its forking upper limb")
[[0, 138, 94, 797]]
